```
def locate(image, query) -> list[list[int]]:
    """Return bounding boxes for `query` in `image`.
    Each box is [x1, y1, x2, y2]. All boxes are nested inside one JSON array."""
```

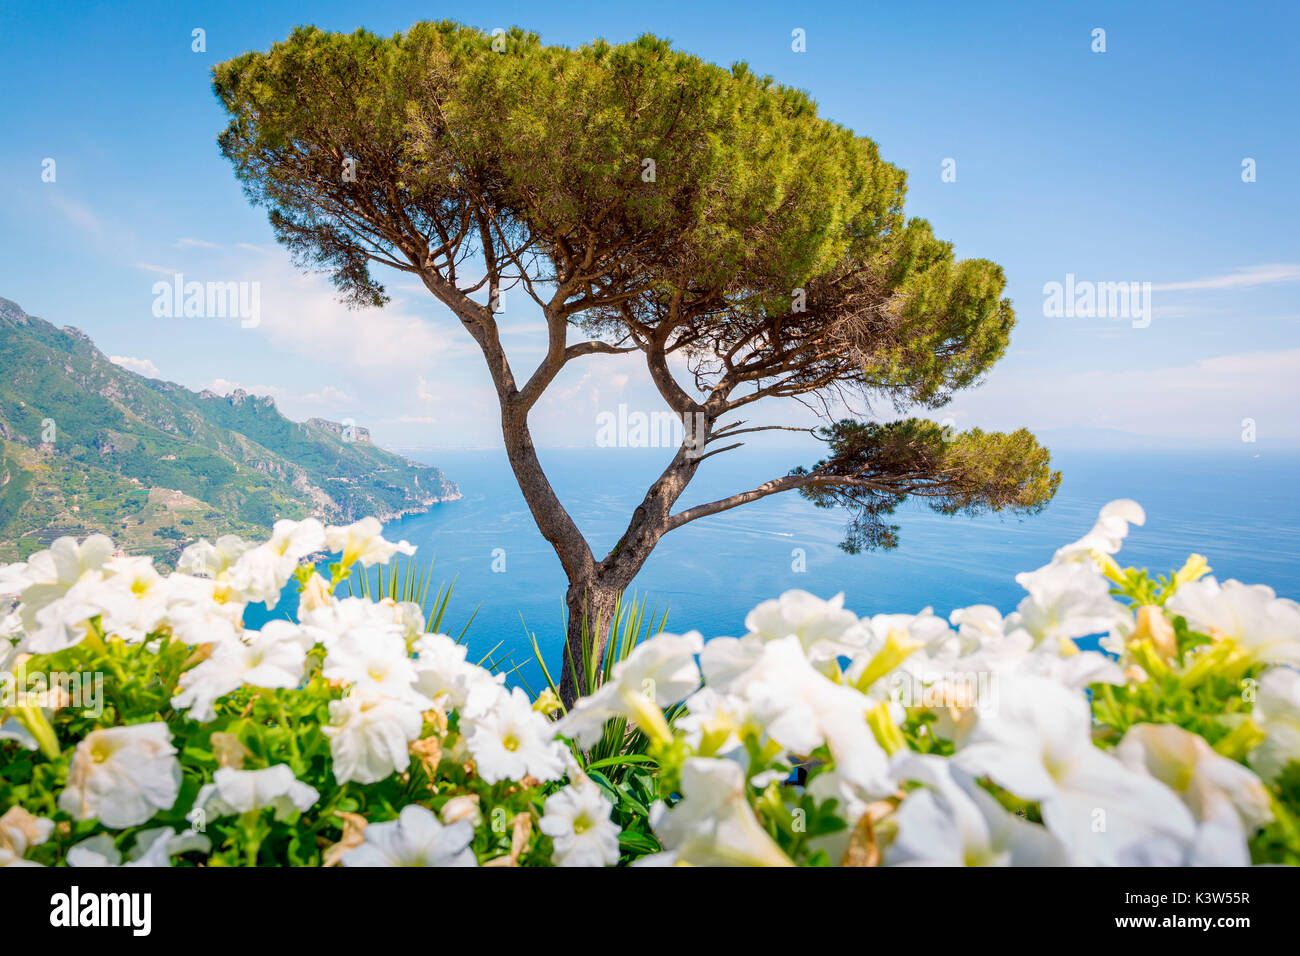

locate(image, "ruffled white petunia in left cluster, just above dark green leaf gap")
[[172, 620, 311, 722]]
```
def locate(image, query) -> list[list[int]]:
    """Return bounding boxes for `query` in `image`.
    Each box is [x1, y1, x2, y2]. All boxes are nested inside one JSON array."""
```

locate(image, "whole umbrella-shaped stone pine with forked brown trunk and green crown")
[[213, 22, 1060, 700]]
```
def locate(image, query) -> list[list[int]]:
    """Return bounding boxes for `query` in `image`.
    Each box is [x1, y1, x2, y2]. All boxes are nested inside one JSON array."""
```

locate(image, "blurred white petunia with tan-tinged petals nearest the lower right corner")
[[1115, 723, 1273, 866]]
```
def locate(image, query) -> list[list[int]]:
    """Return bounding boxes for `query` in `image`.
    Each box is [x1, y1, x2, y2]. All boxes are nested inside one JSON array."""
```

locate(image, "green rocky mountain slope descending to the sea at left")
[[0, 299, 460, 563]]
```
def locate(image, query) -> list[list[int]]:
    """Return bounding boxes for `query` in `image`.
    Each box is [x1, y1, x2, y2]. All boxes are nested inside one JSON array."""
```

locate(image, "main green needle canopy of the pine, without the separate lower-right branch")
[[215, 22, 1013, 416]]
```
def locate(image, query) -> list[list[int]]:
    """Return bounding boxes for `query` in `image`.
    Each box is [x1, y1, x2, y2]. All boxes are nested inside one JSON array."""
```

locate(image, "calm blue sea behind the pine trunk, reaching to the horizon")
[[364, 446, 1300, 687]]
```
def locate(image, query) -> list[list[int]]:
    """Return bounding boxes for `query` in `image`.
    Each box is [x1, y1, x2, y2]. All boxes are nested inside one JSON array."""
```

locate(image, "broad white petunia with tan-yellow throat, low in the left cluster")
[[59, 722, 181, 830]]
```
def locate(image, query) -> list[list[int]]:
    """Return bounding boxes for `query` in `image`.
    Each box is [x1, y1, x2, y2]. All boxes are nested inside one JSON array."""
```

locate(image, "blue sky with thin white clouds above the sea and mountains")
[[0, 0, 1300, 450]]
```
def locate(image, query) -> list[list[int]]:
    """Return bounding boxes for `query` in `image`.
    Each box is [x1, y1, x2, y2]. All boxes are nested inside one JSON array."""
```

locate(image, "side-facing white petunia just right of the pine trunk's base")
[[555, 631, 707, 747]]
